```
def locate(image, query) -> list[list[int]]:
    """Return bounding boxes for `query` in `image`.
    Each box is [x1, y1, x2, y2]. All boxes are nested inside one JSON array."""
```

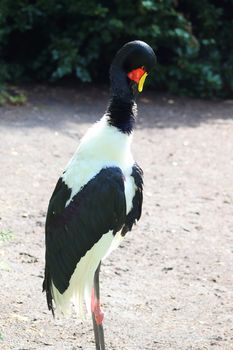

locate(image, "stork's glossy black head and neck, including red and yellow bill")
[[106, 40, 156, 134]]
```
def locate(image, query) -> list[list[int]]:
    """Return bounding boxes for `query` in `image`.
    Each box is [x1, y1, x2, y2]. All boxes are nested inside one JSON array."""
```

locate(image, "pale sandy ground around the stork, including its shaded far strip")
[[0, 86, 233, 350]]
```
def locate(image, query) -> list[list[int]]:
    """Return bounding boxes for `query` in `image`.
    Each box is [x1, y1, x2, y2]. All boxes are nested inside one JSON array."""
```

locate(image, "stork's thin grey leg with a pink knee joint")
[[91, 263, 105, 350]]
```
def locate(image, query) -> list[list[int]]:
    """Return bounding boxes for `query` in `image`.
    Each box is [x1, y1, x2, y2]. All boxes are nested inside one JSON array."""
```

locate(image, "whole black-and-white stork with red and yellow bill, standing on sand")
[[43, 40, 156, 350]]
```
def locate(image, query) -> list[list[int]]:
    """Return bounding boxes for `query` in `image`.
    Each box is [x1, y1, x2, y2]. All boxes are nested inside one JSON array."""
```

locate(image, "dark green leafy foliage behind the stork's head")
[[0, 0, 233, 97]]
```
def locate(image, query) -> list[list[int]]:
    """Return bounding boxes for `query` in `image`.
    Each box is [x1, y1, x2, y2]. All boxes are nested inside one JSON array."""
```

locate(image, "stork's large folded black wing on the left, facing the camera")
[[43, 167, 126, 310]]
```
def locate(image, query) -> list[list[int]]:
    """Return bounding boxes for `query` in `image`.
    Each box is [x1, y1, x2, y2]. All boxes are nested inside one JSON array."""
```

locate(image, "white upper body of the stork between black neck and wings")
[[62, 116, 134, 205]]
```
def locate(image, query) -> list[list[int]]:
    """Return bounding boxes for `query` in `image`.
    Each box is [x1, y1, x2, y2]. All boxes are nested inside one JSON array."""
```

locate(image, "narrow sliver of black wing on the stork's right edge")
[[121, 163, 143, 236]]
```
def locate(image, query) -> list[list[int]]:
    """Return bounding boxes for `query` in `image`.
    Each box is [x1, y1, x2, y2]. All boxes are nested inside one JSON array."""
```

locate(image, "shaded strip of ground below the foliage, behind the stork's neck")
[[0, 86, 233, 129]]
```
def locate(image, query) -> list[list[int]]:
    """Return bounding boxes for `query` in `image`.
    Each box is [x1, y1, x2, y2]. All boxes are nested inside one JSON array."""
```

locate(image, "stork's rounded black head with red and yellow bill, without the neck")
[[110, 40, 156, 96]]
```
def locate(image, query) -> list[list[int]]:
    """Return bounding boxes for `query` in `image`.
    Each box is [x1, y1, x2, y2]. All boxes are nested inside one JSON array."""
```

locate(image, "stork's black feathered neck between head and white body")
[[106, 66, 137, 134]]
